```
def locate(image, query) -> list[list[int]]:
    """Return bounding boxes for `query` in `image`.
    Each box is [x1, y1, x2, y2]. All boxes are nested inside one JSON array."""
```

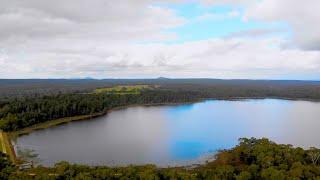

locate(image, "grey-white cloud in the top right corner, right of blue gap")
[[246, 0, 320, 50]]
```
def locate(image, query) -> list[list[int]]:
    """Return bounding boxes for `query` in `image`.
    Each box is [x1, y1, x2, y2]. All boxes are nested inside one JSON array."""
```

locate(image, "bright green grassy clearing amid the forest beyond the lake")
[[94, 85, 153, 94]]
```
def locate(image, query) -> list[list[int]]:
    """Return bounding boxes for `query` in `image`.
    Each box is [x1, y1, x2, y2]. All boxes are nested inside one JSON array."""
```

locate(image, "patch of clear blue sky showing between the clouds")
[[160, 3, 291, 43]]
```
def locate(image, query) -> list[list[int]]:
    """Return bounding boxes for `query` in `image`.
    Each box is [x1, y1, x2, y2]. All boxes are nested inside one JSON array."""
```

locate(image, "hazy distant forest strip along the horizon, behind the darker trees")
[[0, 78, 320, 100]]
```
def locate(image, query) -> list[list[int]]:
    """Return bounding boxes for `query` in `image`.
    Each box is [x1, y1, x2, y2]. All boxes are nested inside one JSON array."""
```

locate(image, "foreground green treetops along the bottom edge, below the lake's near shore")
[[0, 138, 320, 180]]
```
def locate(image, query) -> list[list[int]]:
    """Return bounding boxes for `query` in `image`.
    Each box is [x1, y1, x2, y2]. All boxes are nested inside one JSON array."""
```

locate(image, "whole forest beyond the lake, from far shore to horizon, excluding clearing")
[[0, 79, 320, 131]]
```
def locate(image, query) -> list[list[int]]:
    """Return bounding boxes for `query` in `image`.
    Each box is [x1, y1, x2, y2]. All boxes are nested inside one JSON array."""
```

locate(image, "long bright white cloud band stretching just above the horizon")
[[0, 39, 320, 78]]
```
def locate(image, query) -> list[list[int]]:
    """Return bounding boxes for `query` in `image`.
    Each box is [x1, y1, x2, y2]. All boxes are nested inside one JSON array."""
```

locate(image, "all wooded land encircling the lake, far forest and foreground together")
[[0, 79, 320, 179]]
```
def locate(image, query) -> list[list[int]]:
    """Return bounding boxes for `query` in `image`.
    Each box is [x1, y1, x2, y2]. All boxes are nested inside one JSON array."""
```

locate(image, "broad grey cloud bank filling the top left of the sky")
[[0, 0, 185, 41]]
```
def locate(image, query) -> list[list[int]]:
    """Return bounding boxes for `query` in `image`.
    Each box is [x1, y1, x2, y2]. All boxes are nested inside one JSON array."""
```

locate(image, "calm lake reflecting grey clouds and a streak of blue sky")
[[15, 99, 320, 166]]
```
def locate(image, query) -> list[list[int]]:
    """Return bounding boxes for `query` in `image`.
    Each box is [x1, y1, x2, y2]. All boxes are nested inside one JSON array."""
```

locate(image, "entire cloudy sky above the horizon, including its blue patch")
[[0, 0, 320, 80]]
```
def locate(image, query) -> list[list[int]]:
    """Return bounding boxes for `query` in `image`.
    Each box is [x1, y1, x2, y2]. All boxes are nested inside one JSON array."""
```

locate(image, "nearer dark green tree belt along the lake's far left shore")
[[0, 90, 201, 131]]
